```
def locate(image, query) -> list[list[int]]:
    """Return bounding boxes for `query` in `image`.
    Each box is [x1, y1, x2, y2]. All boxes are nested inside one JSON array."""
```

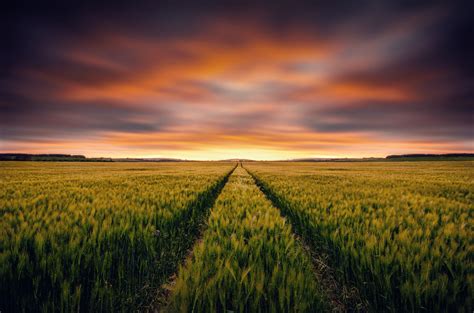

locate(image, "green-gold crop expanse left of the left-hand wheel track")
[[0, 163, 232, 312]]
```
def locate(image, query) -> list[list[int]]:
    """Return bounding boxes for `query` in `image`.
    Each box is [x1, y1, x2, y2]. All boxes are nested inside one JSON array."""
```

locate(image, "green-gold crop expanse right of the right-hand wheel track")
[[246, 162, 474, 312]]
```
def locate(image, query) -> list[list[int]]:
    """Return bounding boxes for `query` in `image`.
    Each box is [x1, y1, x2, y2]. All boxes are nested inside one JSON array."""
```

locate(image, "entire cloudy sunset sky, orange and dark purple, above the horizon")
[[0, 0, 474, 160]]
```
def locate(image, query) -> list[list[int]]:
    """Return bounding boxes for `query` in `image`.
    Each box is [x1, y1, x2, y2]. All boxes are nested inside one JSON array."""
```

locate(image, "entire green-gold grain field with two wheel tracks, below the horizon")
[[0, 161, 474, 313]]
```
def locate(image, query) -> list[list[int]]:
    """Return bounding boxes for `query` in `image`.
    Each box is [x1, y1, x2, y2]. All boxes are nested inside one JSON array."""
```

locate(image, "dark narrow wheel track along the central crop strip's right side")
[[245, 168, 369, 312]]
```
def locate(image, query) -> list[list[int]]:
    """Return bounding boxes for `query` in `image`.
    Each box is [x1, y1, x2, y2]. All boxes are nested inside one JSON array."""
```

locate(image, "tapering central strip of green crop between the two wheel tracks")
[[162, 166, 330, 312]]
